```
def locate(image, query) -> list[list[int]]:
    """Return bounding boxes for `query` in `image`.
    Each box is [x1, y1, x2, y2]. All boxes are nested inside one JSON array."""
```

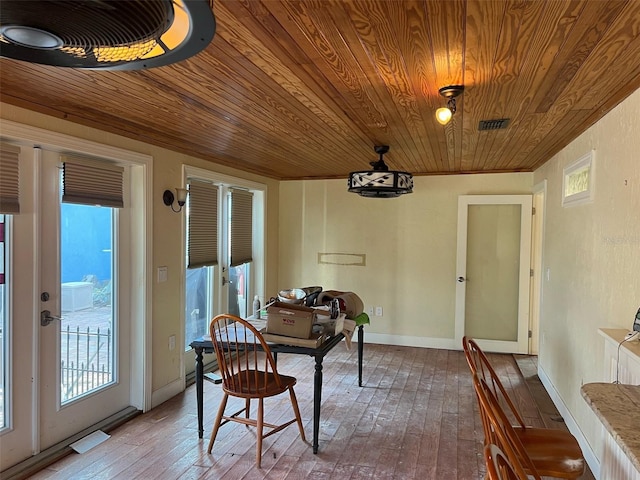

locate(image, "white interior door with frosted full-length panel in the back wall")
[[456, 195, 531, 353]]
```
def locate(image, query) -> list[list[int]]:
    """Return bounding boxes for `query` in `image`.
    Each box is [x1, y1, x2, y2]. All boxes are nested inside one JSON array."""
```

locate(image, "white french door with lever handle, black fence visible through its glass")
[[38, 150, 130, 448]]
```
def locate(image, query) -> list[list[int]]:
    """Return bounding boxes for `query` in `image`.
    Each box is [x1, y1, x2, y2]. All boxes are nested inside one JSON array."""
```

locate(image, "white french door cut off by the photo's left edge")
[[0, 148, 38, 470]]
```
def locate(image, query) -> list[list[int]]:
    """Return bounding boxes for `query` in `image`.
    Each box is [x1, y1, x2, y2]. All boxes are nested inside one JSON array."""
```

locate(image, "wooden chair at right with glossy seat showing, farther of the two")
[[462, 337, 585, 479]]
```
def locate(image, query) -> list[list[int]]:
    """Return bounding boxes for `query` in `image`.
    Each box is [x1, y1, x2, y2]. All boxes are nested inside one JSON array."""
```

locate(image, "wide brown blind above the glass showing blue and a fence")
[[60, 155, 124, 208]]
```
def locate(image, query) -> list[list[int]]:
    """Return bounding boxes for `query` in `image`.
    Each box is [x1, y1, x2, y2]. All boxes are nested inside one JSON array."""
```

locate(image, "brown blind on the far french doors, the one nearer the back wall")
[[230, 188, 253, 267]]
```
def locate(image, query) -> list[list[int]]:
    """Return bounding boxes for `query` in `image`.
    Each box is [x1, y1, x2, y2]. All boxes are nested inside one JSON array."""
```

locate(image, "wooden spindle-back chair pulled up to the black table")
[[207, 314, 306, 468]]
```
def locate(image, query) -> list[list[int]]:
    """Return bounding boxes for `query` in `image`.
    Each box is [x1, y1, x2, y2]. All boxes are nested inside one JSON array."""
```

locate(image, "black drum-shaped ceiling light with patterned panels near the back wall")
[[348, 145, 413, 198]]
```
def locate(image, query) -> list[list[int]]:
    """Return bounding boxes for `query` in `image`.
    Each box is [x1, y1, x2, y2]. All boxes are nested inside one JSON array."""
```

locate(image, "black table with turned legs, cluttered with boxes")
[[189, 325, 364, 453]]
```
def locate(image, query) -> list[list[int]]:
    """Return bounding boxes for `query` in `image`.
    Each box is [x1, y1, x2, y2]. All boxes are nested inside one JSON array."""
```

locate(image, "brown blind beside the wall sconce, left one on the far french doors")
[[187, 180, 218, 268]]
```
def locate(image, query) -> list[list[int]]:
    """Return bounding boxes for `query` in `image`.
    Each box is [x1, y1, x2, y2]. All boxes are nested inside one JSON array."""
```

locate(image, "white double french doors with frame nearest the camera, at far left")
[[0, 127, 151, 470]]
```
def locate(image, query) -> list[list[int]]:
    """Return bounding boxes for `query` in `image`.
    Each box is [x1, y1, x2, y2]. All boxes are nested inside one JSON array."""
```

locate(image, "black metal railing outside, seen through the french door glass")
[[60, 326, 114, 403]]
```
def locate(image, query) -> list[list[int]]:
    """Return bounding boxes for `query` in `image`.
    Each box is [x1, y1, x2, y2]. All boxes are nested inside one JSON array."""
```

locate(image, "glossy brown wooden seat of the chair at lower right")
[[514, 427, 585, 478]]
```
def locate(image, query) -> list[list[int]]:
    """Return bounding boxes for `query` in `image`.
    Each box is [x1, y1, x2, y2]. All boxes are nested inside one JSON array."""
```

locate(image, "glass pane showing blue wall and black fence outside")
[[60, 203, 115, 404]]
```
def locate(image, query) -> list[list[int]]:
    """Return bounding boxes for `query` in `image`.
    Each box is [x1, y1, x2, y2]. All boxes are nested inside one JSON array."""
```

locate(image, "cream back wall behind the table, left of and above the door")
[[278, 173, 533, 349]]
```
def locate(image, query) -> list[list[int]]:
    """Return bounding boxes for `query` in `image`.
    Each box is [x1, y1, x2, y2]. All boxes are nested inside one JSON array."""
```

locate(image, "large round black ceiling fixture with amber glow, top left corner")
[[0, 0, 216, 70]]
